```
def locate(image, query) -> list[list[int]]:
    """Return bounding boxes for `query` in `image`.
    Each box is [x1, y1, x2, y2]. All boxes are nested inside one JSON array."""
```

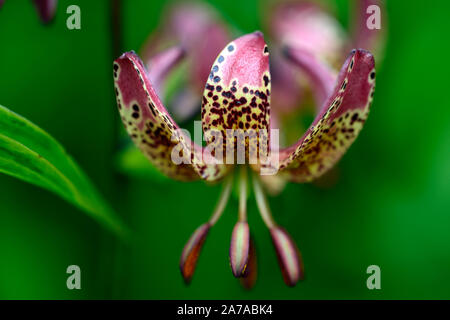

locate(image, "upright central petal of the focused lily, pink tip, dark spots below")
[[202, 32, 270, 160]]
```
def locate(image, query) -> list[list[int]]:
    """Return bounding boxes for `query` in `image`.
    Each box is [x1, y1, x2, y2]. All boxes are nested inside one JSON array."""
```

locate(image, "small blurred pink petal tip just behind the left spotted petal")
[[147, 47, 185, 94]]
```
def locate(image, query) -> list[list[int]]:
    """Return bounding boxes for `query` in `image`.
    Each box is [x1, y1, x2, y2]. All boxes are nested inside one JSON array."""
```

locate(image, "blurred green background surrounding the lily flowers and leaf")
[[0, 0, 450, 299]]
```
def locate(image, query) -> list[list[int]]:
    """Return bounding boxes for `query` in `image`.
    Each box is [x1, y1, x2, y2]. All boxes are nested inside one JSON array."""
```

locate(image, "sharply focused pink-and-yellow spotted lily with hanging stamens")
[[114, 28, 375, 286]]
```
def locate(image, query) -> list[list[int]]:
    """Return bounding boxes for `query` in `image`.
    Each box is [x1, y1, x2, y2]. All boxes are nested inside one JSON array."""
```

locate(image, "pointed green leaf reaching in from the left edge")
[[0, 105, 128, 236]]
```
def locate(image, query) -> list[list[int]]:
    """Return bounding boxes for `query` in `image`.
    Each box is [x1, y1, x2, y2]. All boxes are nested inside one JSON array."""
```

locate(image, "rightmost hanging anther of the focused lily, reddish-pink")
[[270, 227, 303, 287]]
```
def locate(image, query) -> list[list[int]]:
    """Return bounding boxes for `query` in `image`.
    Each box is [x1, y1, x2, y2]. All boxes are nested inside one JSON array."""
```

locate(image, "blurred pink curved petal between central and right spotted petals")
[[284, 48, 336, 110]]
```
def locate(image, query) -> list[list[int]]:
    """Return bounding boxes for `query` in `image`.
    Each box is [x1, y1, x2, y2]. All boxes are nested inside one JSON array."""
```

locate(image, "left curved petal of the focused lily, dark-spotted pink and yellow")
[[114, 52, 226, 181]]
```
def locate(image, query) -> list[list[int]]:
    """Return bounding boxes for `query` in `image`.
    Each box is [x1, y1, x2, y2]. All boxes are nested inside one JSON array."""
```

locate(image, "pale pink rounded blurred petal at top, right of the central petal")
[[271, 2, 346, 64]]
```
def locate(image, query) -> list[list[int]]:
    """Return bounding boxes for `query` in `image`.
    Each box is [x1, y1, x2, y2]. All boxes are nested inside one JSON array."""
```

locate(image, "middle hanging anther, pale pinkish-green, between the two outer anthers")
[[230, 221, 250, 278]]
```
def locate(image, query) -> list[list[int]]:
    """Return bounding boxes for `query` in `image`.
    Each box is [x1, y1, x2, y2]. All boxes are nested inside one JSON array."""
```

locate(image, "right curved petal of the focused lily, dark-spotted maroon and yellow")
[[278, 49, 375, 182]]
